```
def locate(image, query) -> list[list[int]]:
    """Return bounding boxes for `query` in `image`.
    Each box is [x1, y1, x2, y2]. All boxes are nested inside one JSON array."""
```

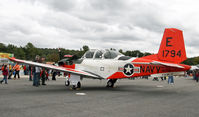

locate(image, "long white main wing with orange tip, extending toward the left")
[[9, 58, 98, 78]]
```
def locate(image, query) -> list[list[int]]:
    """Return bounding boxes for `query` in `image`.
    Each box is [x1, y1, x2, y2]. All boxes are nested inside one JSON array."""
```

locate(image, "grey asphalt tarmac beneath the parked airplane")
[[0, 76, 199, 117]]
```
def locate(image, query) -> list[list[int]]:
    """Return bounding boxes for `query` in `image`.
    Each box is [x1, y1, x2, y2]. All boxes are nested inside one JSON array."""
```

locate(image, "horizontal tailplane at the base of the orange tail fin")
[[132, 61, 184, 68]]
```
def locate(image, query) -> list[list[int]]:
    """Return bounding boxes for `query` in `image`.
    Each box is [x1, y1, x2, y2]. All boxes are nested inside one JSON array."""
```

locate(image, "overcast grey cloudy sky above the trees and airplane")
[[0, 0, 199, 57]]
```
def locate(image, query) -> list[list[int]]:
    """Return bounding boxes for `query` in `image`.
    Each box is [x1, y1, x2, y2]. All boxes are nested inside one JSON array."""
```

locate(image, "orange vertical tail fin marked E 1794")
[[157, 28, 187, 63]]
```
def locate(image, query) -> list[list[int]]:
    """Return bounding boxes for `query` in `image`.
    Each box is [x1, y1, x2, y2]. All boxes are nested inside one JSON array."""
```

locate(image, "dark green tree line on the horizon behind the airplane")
[[0, 43, 199, 65]]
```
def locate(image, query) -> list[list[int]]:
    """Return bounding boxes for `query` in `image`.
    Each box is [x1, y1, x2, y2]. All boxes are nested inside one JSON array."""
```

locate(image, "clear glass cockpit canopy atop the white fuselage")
[[82, 49, 124, 59]]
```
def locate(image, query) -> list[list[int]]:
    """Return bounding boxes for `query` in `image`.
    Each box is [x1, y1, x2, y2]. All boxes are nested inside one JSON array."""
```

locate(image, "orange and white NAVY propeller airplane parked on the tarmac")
[[9, 28, 191, 90]]
